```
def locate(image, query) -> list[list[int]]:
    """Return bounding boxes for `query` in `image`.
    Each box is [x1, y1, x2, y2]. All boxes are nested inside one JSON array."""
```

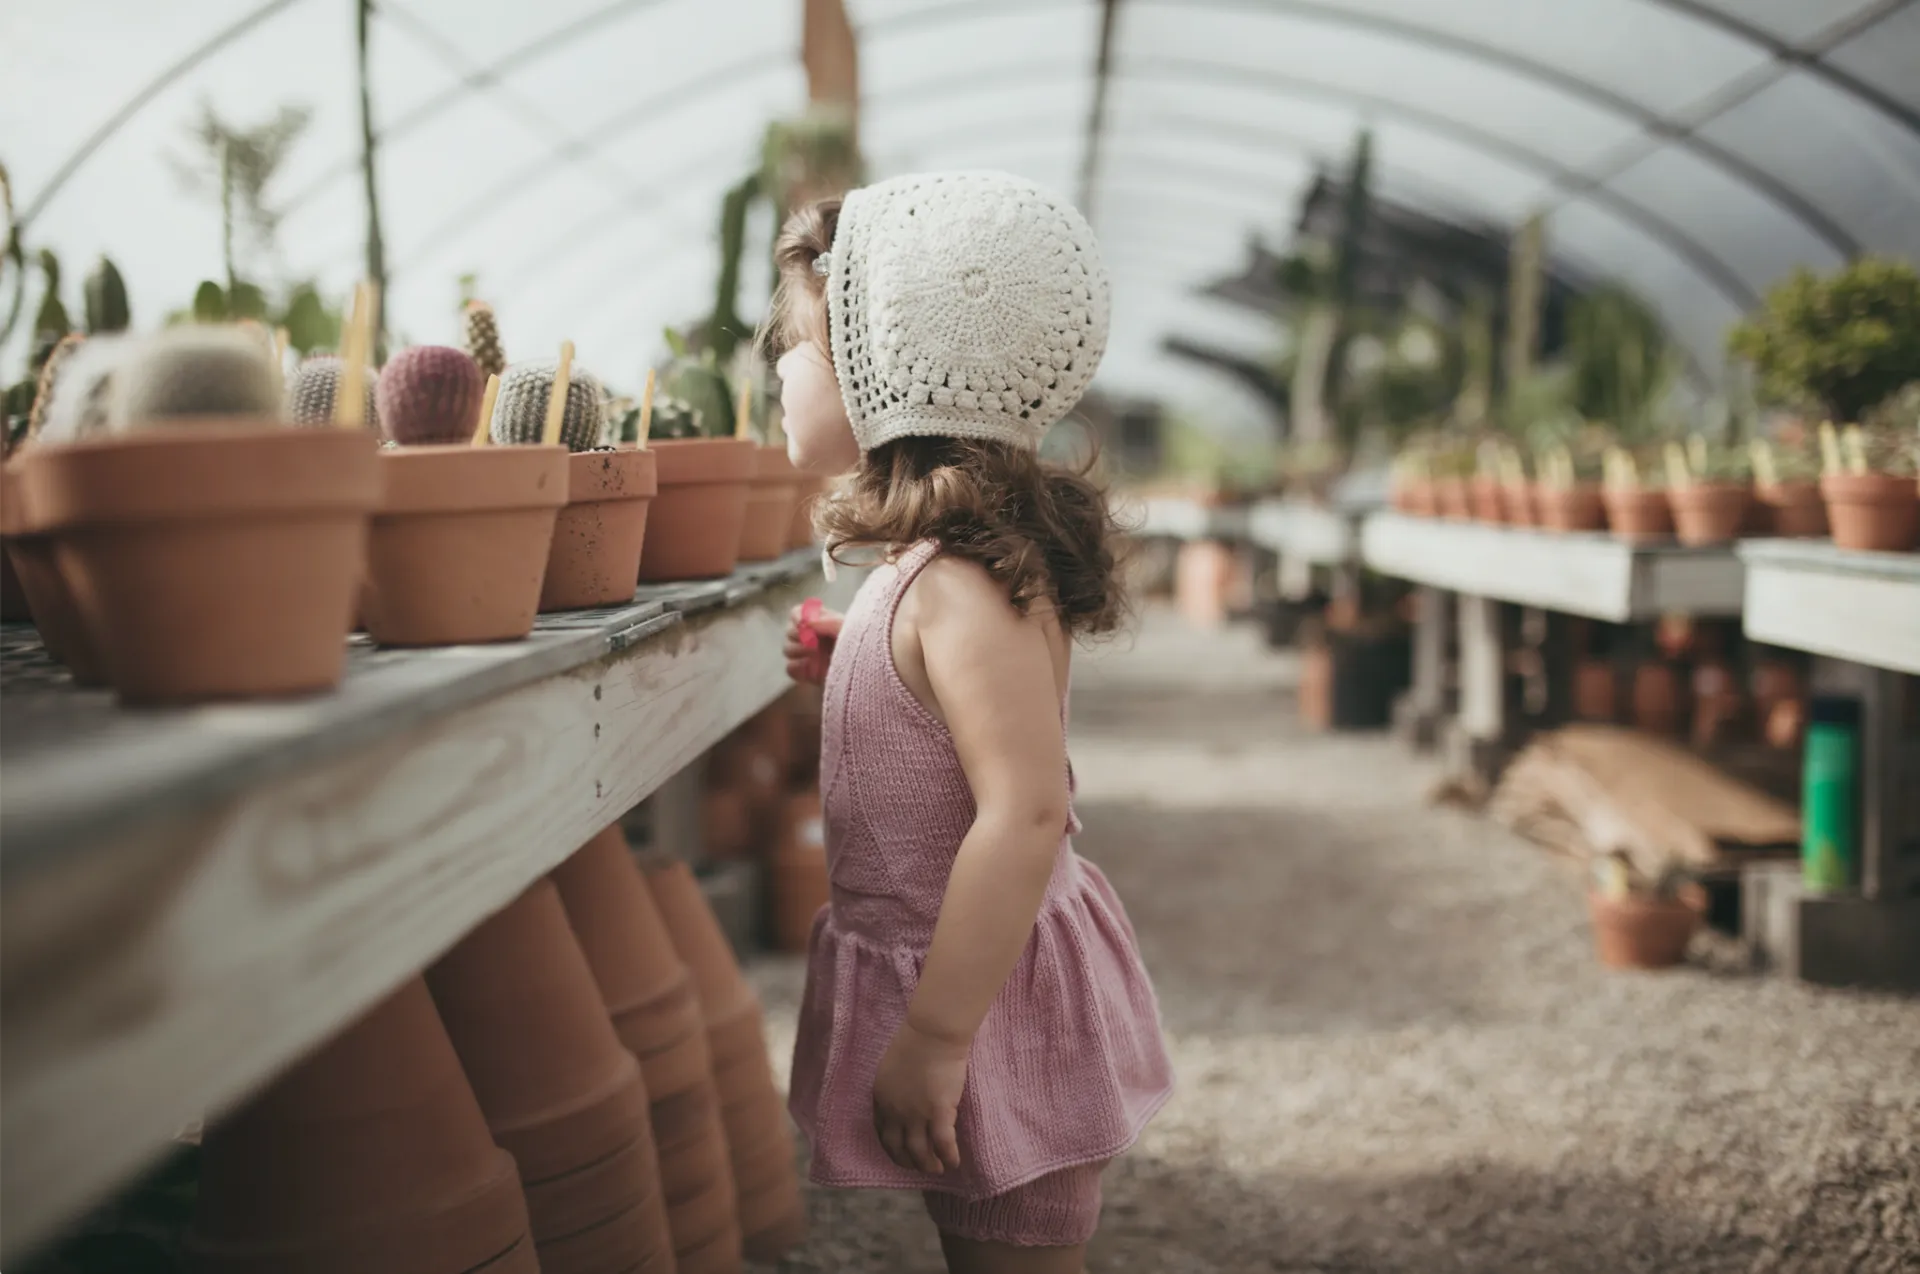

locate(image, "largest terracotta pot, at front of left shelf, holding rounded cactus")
[[15, 420, 380, 704]]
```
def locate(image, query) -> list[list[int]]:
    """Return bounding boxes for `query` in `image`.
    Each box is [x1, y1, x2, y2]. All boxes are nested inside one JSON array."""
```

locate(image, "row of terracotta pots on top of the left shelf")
[[0, 422, 816, 704]]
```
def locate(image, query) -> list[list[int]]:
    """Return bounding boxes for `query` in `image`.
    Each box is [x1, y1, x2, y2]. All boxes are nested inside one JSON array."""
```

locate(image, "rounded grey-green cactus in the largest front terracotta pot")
[[108, 324, 280, 432]]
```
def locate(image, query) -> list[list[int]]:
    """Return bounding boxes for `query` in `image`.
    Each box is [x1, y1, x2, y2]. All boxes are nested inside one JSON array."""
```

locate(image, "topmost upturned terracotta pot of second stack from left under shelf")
[[426, 881, 647, 1182]]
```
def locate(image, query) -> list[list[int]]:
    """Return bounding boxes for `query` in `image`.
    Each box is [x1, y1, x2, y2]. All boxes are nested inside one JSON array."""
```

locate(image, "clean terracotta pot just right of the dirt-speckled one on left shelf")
[[639, 437, 758, 583]]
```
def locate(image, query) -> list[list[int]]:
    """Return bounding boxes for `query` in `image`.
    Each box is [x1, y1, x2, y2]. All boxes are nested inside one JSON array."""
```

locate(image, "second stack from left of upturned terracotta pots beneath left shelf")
[[426, 881, 674, 1274]]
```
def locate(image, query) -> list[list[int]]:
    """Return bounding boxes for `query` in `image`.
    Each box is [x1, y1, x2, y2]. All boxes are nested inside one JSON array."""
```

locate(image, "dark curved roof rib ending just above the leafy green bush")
[[1135, 0, 1858, 257]]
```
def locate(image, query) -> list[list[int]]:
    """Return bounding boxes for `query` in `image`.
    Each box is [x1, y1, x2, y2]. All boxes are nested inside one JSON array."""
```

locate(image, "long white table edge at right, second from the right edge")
[[1361, 512, 1741, 624]]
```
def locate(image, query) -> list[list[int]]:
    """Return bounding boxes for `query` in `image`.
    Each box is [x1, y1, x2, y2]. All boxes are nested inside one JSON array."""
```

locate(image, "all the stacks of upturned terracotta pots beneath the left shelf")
[[188, 827, 804, 1274]]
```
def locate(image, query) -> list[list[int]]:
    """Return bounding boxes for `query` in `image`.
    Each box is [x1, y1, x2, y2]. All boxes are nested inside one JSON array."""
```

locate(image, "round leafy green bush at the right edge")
[[1728, 257, 1920, 422]]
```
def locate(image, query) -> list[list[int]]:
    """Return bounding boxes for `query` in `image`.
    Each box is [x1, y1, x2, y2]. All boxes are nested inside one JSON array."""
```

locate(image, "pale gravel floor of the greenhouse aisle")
[[753, 614, 1920, 1274]]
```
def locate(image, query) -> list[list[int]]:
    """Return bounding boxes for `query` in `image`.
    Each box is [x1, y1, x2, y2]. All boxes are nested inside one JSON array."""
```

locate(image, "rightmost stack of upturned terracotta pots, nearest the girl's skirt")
[[647, 863, 806, 1274]]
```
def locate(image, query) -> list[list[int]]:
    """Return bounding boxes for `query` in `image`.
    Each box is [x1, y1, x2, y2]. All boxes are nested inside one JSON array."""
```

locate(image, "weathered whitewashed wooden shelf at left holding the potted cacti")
[[0, 551, 818, 1261]]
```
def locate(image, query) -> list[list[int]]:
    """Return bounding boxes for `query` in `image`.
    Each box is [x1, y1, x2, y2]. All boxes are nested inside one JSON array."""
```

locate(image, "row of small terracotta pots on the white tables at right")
[[1394, 474, 1920, 551]]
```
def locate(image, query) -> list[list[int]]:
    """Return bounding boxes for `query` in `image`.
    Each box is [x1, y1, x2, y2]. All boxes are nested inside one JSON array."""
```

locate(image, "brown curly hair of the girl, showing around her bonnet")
[[760, 200, 1127, 637]]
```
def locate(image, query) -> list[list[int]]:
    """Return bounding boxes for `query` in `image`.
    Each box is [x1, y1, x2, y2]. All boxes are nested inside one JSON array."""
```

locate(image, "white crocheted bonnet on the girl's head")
[[826, 173, 1110, 451]]
